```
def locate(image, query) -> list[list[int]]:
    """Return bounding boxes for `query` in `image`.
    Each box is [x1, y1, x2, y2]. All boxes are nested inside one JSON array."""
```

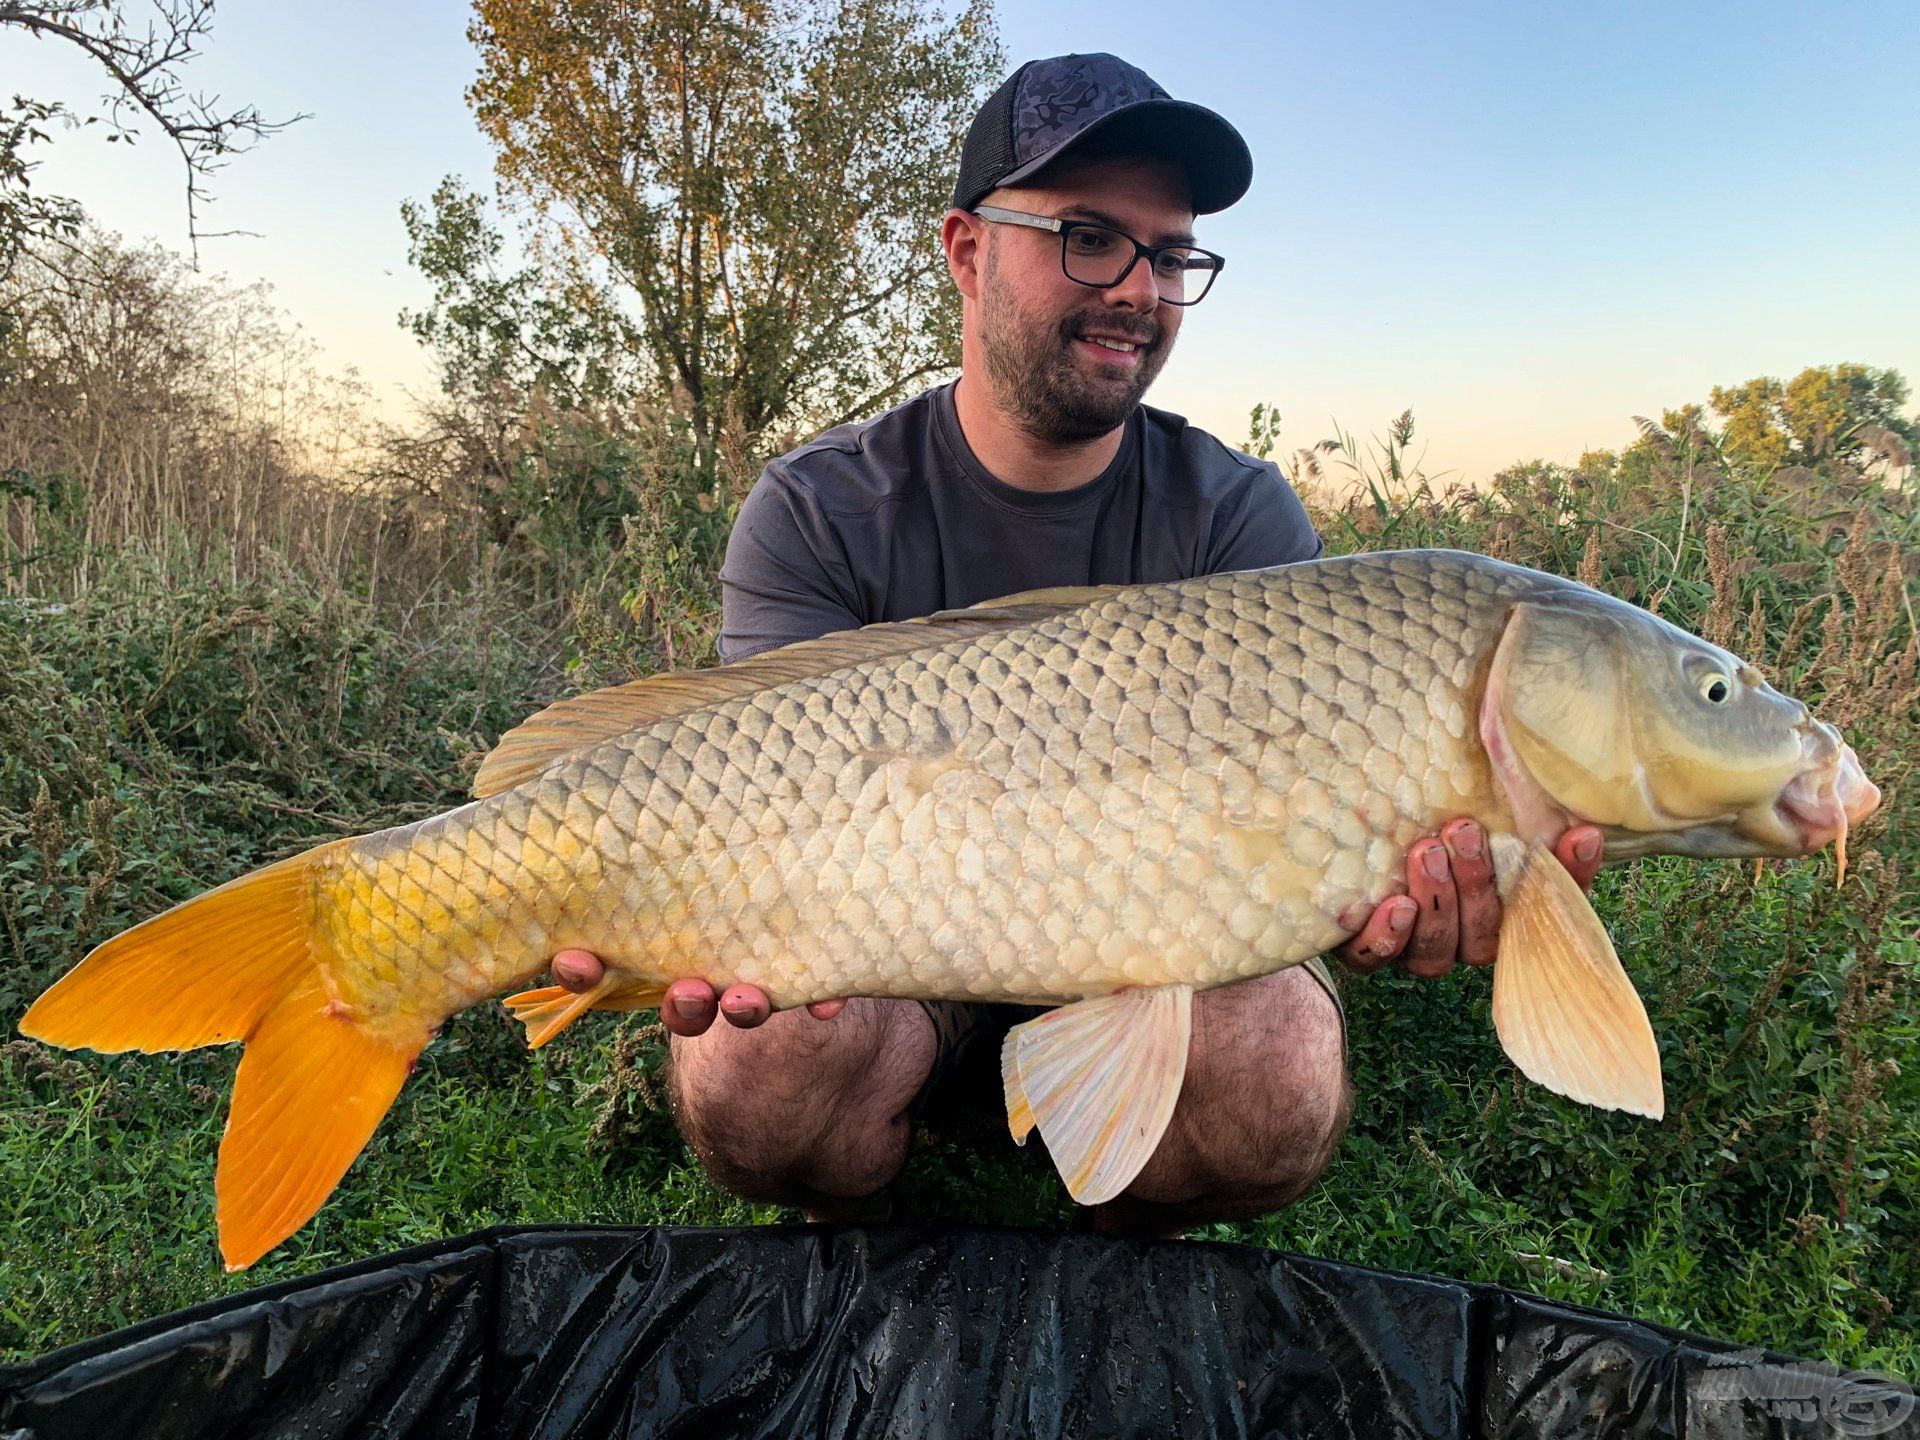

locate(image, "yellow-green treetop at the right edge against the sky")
[[1713, 365, 1920, 472]]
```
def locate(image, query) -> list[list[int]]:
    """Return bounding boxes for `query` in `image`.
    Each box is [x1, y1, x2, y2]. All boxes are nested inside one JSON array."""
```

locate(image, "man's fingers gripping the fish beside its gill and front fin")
[[1334, 820, 1603, 975]]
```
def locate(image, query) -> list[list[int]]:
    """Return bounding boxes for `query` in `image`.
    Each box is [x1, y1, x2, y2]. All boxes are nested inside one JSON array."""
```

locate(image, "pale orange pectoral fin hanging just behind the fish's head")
[[1494, 843, 1667, 1119]]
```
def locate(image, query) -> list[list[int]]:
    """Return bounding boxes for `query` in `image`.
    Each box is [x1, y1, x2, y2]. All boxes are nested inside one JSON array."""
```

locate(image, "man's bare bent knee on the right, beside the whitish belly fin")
[[1092, 966, 1354, 1236]]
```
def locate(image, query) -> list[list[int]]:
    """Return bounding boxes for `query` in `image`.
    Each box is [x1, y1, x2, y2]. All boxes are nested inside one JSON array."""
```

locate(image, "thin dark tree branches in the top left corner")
[[0, 0, 303, 278]]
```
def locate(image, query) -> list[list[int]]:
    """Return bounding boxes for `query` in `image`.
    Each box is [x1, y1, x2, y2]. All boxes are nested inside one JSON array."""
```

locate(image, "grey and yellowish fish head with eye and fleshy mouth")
[[1480, 595, 1880, 858]]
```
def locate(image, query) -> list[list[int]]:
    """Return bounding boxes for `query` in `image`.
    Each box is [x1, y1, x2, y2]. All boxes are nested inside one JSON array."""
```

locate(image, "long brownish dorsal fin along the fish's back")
[[474, 586, 1119, 801]]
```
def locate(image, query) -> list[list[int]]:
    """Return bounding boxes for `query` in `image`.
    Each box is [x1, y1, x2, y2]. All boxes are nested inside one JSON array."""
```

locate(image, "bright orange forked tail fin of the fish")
[[19, 841, 428, 1269]]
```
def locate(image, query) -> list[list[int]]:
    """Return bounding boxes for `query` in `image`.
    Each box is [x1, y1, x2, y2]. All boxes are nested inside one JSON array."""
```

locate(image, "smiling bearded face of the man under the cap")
[[977, 159, 1192, 444]]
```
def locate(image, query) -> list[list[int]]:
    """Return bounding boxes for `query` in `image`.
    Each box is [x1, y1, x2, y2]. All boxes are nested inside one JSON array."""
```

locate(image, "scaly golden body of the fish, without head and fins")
[[319, 555, 1540, 1023]]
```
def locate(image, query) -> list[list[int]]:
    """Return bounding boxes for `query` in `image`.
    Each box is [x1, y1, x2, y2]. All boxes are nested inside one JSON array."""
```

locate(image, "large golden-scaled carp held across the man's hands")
[[21, 551, 1878, 1269]]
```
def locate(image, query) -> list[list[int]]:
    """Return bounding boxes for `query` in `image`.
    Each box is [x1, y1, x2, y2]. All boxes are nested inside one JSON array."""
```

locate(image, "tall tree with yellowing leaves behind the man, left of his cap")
[[468, 0, 1000, 445]]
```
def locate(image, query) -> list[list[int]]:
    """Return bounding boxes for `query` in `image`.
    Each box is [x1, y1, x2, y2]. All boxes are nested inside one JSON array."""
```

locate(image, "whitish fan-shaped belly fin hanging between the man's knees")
[[1000, 985, 1194, 1206]]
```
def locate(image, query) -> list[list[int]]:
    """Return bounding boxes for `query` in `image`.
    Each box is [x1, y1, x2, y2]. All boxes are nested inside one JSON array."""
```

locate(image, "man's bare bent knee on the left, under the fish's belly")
[[668, 1000, 933, 1219]]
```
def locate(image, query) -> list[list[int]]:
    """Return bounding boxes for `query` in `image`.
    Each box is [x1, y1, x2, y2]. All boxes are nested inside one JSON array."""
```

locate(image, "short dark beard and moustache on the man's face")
[[979, 253, 1173, 445]]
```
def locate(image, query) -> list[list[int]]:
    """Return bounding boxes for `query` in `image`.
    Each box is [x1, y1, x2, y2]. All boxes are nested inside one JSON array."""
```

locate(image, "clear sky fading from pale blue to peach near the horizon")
[[0, 0, 1920, 480]]
